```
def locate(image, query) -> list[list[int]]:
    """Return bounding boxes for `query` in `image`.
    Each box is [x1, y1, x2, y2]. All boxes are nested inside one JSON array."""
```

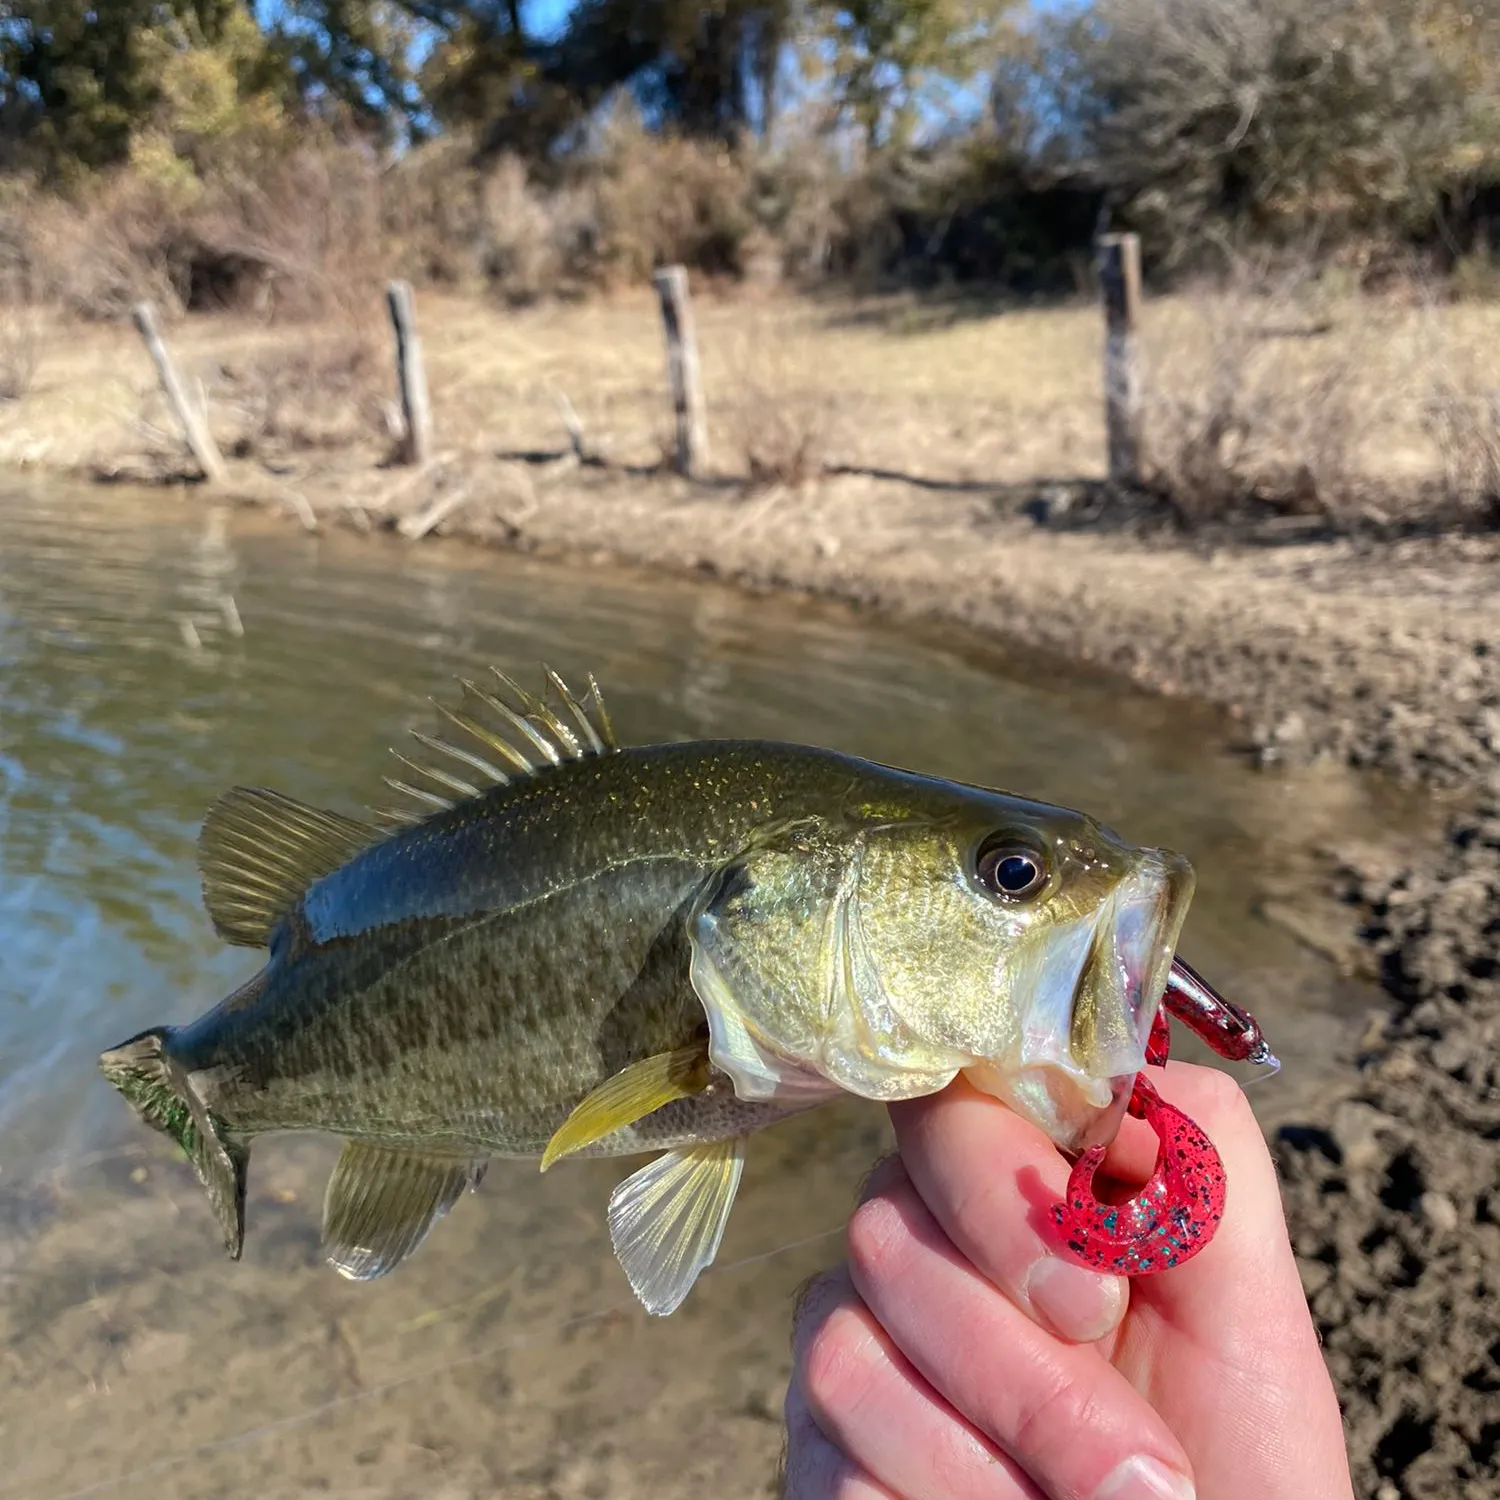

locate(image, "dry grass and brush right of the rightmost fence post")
[[1143, 276, 1500, 524]]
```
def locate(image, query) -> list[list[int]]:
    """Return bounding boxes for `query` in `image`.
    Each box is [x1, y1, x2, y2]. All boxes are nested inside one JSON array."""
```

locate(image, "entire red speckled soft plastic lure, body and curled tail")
[[1052, 959, 1281, 1277]]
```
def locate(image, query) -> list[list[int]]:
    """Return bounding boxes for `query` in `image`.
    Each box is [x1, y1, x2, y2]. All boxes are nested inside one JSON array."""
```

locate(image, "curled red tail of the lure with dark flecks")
[[1052, 1074, 1224, 1277]]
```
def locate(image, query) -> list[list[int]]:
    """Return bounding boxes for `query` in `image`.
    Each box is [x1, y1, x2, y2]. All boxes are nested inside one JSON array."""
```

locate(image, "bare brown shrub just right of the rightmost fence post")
[[1143, 272, 1376, 524]]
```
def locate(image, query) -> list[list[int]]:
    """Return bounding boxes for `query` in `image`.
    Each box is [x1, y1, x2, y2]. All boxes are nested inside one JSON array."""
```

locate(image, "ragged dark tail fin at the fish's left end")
[[99, 1026, 249, 1260]]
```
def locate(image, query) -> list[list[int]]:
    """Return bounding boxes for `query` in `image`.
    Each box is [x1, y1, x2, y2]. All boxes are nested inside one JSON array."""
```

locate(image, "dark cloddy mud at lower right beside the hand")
[[1280, 780, 1500, 1500]]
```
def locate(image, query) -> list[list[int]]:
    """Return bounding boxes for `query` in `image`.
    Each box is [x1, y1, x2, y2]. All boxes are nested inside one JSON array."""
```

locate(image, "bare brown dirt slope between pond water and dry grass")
[[234, 464, 1500, 786]]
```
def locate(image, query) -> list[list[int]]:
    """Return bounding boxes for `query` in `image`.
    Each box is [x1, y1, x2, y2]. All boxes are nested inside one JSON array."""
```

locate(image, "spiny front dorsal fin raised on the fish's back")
[[380, 666, 618, 824]]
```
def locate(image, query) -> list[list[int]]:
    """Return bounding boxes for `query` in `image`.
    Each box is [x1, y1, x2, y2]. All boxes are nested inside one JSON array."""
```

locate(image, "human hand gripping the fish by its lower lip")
[[785, 1064, 1353, 1500]]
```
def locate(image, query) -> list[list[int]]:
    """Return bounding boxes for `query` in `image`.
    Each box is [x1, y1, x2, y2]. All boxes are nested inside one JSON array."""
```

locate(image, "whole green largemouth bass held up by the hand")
[[99, 669, 1196, 1316]]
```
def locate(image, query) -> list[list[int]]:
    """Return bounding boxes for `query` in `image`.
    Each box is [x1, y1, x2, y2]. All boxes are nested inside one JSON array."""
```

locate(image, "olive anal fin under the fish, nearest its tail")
[[323, 1140, 486, 1281]]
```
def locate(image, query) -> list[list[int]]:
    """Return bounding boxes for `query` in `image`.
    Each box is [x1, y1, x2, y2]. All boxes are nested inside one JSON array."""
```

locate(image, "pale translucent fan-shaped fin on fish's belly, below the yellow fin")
[[609, 1136, 746, 1317]]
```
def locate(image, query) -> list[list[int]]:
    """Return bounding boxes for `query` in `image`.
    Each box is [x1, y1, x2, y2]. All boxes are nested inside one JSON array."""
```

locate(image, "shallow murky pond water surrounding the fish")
[[0, 488, 1428, 1497]]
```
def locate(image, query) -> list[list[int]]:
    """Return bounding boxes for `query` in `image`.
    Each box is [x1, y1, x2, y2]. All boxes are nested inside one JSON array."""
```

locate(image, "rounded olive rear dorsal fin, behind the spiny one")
[[198, 786, 384, 948]]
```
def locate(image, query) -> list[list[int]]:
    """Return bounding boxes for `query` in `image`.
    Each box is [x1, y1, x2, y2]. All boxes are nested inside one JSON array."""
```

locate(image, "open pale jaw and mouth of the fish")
[[963, 849, 1194, 1152]]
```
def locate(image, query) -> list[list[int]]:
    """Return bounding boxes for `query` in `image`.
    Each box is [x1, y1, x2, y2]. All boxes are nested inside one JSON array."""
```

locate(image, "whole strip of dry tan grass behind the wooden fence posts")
[[0, 284, 1500, 534]]
